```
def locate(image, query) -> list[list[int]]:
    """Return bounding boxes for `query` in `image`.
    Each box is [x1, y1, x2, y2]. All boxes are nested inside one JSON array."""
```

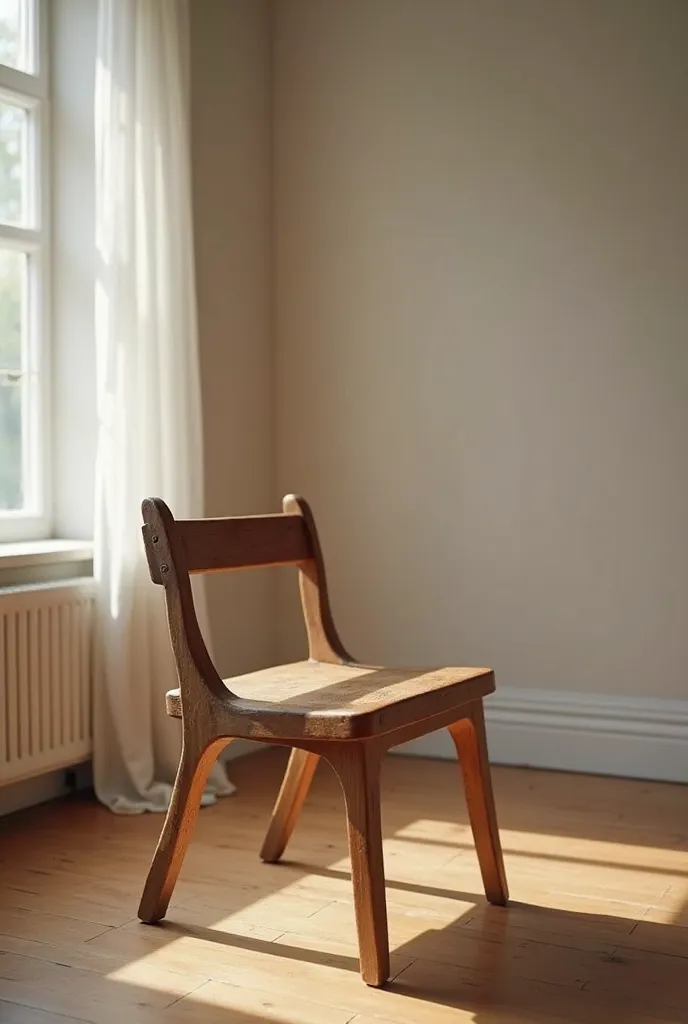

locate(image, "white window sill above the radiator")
[[0, 540, 93, 587]]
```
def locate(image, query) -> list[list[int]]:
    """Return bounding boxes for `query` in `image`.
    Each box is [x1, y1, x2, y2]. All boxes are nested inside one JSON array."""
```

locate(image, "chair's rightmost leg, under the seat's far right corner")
[[449, 700, 509, 906]]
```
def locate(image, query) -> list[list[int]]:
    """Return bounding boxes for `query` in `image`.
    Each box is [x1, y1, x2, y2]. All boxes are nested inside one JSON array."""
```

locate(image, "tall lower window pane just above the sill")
[[0, 250, 25, 512]]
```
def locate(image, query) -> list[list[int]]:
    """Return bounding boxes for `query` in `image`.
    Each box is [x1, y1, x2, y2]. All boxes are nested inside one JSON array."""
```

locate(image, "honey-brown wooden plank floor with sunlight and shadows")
[[0, 752, 688, 1024]]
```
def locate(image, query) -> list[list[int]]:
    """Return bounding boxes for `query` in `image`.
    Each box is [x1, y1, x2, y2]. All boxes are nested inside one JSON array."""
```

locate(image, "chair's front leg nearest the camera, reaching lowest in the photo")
[[326, 742, 389, 987]]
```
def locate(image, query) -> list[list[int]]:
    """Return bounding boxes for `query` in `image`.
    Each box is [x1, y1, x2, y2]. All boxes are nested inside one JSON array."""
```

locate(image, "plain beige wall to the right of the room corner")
[[272, 0, 688, 697]]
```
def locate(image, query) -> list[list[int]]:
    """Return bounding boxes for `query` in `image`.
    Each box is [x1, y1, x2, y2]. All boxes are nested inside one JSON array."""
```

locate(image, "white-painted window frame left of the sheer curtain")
[[0, 0, 52, 543]]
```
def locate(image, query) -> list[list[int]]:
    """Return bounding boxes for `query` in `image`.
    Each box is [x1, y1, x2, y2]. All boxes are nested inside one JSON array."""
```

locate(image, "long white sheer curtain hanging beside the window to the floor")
[[94, 0, 231, 814]]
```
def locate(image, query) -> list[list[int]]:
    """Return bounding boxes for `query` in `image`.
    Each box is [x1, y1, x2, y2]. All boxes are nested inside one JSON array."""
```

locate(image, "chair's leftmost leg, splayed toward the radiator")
[[138, 737, 228, 925]]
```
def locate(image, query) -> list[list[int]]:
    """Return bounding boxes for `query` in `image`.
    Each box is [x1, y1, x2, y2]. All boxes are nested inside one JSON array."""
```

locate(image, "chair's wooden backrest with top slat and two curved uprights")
[[141, 495, 353, 674]]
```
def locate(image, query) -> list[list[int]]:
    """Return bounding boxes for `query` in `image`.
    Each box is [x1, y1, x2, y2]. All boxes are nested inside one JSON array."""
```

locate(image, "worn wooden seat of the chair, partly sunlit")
[[167, 662, 495, 739]]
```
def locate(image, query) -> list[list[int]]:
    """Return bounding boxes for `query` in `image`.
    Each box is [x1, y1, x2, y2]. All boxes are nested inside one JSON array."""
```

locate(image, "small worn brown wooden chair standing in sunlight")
[[138, 497, 508, 985]]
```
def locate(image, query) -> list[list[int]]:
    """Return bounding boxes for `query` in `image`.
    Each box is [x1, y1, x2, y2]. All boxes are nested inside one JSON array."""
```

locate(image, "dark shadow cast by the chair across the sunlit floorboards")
[[150, 876, 688, 1024]]
